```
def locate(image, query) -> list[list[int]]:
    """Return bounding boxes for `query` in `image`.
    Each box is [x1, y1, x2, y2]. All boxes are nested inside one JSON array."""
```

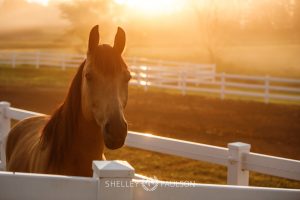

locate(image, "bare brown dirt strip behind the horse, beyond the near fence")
[[0, 85, 300, 160]]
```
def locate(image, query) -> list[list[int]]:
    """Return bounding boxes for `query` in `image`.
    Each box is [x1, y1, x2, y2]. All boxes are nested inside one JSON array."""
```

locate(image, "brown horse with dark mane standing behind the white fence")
[[6, 25, 131, 176]]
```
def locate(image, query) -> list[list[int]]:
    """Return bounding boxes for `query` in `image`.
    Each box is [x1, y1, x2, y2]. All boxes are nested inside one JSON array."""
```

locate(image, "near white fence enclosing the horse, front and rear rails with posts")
[[0, 102, 300, 200]]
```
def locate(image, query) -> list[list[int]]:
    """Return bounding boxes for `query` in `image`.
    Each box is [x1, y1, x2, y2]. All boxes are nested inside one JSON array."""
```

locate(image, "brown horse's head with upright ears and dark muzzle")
[[81, 26, 131, 149]]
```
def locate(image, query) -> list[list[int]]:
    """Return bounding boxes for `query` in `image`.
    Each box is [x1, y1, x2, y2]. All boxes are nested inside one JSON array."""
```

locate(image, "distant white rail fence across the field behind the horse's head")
[[0, 51, 300, 103]]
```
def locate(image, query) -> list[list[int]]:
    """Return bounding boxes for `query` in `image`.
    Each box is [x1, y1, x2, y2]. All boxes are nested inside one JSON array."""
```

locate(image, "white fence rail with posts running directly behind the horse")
[[0, 102, 300, 185]]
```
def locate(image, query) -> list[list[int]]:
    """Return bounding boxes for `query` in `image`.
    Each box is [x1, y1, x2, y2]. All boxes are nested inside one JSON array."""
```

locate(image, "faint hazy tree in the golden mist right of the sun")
[[193, 0, 239, 63]]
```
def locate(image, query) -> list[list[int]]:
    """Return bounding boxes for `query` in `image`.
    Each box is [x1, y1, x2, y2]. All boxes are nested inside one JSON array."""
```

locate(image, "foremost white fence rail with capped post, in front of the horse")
[[0, 161, 300, 200]]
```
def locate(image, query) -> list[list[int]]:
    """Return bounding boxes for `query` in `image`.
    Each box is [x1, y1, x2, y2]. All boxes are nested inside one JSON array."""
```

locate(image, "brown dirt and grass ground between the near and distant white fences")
[[0, 66, 300, 188]]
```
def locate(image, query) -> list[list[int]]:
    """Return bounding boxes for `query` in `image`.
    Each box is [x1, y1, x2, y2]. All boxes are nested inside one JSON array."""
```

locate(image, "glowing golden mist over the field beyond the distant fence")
[[0, 0, 300, 77]]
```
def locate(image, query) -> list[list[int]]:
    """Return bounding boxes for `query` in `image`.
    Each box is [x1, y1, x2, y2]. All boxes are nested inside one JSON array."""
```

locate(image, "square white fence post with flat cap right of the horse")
[[227, 142, 251, 186]]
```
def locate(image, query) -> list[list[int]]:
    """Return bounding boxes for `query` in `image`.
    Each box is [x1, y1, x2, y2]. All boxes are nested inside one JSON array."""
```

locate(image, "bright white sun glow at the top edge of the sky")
[[114, 0, 186, 15]]
